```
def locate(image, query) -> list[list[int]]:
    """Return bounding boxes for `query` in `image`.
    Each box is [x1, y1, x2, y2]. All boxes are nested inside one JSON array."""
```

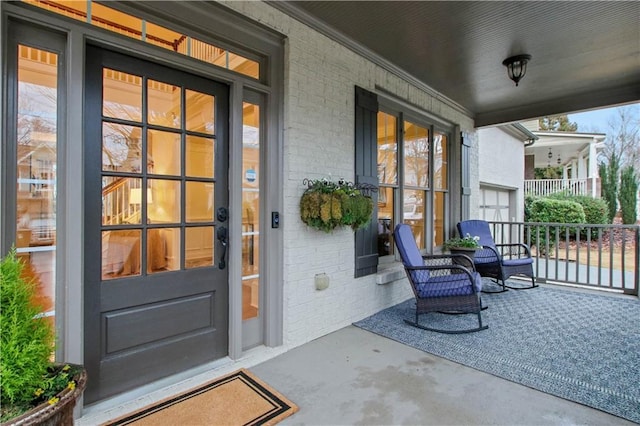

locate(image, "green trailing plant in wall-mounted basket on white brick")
[[300, 180, 373, 232]]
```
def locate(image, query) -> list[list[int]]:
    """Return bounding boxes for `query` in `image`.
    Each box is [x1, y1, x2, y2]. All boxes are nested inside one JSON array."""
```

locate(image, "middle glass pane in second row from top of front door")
[[147, 130, 181, 176]]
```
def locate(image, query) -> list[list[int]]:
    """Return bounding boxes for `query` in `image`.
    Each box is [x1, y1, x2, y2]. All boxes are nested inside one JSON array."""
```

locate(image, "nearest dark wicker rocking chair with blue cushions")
[[393, 224, 489, 334]]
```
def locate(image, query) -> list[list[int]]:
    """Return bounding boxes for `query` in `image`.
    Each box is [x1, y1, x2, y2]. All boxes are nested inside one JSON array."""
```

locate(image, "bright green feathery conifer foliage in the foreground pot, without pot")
[[0, 249, 54, 406]]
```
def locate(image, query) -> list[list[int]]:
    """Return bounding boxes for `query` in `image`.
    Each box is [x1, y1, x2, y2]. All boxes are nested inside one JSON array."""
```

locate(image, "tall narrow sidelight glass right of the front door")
[[242, 102, 260, 319]]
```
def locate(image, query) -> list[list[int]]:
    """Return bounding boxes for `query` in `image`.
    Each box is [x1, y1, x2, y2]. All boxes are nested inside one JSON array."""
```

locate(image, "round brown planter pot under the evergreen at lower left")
[[2, 368, 87, 426]]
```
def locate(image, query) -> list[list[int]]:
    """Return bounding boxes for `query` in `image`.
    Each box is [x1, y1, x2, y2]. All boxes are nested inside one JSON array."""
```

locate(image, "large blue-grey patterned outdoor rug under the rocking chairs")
[[354, 280, 640, 423]]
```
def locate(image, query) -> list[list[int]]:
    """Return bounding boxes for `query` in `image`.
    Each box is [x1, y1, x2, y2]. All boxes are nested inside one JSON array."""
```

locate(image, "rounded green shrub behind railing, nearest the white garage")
[[528, 198, 585, 252]]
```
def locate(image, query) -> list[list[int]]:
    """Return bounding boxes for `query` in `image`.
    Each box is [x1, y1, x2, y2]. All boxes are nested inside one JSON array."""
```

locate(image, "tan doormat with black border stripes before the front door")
[[105, 369, 298, 426]]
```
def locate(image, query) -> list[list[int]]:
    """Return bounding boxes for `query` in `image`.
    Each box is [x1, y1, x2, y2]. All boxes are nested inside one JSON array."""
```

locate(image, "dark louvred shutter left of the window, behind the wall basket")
[[355, 87, 378, 278]]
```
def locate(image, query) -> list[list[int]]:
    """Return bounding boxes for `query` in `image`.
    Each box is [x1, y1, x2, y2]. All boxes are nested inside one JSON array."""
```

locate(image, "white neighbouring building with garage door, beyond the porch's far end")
[[478, 123, 538, 222]]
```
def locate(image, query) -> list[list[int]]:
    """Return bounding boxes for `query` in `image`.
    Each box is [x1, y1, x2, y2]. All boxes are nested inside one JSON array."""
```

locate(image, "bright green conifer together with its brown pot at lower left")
[[0, 249, 86, 425]]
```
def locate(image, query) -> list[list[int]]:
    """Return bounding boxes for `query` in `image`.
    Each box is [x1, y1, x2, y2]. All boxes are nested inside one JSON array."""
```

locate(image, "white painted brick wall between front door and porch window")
[[224, 1, 478, 347]]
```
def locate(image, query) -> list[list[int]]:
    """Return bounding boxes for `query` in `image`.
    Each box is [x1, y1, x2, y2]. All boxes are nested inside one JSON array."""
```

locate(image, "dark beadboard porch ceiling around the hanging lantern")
[[269, 1, 640, 127]]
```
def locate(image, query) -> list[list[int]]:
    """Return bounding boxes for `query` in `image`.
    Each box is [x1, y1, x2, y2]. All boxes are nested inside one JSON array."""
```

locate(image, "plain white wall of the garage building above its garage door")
[[477, 127, 524, 221]]
